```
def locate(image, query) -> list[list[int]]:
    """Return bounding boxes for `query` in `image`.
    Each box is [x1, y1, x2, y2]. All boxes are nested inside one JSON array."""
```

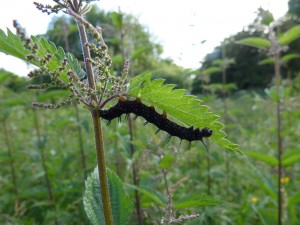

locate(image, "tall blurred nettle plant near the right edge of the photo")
[[237, 13, 300, 225]]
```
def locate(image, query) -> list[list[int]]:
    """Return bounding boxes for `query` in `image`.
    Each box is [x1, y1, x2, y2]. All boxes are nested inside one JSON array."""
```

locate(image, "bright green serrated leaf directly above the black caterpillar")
[[128, 74, 242, 154]]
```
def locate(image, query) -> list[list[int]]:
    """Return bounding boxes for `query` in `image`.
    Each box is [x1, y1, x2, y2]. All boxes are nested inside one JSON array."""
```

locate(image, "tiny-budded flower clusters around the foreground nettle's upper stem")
[[14, 0, 129, 109]]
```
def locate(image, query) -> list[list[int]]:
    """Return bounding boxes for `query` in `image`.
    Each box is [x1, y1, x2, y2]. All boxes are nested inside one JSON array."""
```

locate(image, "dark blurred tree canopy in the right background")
[[193, 6, 300, 93]]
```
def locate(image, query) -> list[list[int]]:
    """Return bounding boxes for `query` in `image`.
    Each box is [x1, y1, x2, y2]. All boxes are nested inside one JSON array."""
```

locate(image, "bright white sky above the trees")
[[0, 0, 288, 76]]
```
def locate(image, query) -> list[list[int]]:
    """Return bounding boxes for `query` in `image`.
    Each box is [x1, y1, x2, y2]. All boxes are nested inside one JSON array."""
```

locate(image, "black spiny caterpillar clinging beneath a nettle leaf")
[[99, 100, 212, 144]]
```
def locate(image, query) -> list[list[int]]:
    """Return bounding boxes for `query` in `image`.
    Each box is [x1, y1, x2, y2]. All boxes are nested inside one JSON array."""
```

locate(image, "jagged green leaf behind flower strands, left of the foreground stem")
[[0, 29, 85, 81]]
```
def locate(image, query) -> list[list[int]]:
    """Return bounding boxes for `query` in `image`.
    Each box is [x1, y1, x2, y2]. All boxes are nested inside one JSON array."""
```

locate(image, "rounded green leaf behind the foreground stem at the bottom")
[[83, 167, 133, 225]]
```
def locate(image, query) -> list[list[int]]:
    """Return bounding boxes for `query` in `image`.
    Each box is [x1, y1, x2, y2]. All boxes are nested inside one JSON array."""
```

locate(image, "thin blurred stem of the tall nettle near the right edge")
[[274, 53, 283, 225]]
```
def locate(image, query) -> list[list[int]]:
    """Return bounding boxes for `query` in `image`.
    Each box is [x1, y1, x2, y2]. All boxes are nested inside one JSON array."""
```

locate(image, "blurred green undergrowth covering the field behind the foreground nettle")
[[0, 72, 300, 225]]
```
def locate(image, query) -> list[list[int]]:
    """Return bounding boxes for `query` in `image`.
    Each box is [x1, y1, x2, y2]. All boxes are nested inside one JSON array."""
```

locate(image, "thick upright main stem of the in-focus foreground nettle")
[[77, 16, 114, 225]]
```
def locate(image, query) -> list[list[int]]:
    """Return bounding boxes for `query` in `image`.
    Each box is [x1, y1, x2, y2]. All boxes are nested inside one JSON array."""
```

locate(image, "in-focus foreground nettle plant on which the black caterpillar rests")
[[0, 0, 241, 225]]
